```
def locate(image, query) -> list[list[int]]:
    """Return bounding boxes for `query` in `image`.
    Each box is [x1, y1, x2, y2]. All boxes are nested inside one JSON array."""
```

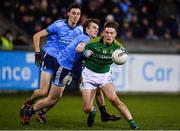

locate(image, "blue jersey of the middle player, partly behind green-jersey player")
[[57, 34, 90, 70]]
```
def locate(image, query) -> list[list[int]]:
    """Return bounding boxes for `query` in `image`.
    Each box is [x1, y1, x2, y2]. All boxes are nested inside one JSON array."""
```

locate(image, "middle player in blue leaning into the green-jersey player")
[[20, 19, 120, 123]]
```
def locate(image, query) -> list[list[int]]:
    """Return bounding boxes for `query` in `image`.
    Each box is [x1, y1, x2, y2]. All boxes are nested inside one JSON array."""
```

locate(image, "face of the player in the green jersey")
[[103, 27, 117, 44]]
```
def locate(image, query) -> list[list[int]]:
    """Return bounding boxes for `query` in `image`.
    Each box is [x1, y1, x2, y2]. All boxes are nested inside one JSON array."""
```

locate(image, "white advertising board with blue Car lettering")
[[112, 54, 180, 92]]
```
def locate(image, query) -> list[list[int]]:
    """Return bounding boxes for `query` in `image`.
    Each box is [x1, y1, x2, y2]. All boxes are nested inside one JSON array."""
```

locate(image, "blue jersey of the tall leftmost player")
[[44, 20, 83, 58]]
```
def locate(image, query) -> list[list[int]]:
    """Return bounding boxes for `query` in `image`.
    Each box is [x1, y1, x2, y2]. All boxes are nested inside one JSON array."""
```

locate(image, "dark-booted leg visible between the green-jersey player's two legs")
[[96, 89, 121, 122]]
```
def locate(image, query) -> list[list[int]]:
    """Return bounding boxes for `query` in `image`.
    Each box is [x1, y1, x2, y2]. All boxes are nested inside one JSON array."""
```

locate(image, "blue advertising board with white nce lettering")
[[0, 51, 40, 90]]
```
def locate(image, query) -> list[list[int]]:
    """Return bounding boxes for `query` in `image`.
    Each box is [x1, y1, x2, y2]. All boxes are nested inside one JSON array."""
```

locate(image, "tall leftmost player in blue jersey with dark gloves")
[[20, 4, 83, 124]]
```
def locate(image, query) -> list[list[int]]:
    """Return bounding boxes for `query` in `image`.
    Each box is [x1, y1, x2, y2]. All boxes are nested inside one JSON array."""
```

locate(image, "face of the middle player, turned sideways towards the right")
[[86, 22, 99, 38]]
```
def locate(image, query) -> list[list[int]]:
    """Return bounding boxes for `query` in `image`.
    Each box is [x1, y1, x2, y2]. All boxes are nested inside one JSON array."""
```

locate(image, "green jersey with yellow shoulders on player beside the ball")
[[85, 37, 123, 73]]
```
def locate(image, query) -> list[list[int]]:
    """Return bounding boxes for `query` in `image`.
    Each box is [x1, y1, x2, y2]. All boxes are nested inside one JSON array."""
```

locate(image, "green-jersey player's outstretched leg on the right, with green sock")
[[102, 83, 139, 129]]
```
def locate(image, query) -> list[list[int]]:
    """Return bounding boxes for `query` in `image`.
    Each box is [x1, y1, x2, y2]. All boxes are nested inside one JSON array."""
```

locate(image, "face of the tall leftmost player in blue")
[[68, 8, 81, 25]]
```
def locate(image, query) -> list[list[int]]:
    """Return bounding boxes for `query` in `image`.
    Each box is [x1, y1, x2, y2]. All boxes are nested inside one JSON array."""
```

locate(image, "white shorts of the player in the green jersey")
[[82, 68, 112, 89]]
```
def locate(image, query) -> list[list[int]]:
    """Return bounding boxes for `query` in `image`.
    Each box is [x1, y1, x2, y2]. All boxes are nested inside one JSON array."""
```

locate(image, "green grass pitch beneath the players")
[[0, 94, 180, 130]]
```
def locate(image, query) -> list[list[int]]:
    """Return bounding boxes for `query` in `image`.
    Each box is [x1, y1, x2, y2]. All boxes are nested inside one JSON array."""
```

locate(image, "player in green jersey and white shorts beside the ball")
[[82, 21, 139, 129]]
